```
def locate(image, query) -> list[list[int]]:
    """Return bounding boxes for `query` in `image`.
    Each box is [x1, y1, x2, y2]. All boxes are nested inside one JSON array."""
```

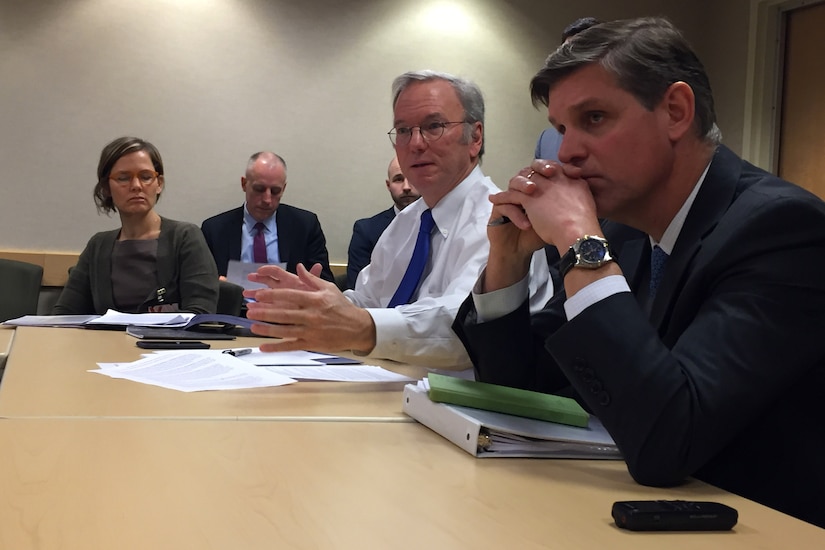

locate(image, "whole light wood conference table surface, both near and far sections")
[[0, 328, 825, 550]]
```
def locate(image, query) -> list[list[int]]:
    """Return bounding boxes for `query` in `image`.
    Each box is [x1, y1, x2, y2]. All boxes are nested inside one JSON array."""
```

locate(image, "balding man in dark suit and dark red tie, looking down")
[[201, 151, 334, 281]]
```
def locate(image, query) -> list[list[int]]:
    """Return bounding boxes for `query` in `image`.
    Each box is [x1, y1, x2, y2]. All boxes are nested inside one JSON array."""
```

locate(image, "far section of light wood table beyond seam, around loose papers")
[[0, 327, 427, 422]]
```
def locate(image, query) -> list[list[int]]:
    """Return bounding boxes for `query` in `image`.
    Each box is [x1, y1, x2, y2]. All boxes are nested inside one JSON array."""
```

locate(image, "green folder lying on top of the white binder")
[[427, 373, 590, 428]]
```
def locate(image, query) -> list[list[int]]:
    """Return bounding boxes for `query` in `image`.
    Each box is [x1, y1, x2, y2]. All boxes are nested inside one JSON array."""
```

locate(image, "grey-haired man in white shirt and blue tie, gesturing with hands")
[[245, 71, 553, 368]]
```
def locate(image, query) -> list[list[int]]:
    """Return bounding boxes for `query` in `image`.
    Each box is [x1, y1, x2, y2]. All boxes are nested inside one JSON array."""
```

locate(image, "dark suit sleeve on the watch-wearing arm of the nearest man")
[[547, 196, 825, 485]]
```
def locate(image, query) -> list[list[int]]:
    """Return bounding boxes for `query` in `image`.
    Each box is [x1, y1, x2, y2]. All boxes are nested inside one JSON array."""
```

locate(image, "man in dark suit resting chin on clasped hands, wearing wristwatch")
[[454, 18, 825, 527]]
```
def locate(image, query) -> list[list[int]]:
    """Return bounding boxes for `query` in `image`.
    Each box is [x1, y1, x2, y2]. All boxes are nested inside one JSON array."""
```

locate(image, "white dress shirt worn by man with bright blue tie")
[[344, 166, 553, 369]]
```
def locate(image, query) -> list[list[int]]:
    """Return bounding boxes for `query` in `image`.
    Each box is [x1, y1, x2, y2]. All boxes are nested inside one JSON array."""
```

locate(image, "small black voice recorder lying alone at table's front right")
[[613, 500, 739, 531]]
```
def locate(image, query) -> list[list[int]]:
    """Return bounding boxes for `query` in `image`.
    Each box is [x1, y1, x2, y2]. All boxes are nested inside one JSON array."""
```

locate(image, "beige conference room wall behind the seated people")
[[0, 0, 749, 262]]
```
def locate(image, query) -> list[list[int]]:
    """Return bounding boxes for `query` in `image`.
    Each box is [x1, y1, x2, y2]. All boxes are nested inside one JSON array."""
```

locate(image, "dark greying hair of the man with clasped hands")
[[530, 17, 722, 145]]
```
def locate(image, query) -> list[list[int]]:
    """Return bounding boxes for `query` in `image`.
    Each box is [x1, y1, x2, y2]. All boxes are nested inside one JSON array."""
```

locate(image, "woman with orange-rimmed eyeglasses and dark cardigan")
[[52, 137, 218, 315]]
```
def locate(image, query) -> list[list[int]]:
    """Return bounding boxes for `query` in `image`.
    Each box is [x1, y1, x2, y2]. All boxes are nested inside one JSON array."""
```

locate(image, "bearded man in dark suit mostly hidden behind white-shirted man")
[[347, 157, 421, 288]]
